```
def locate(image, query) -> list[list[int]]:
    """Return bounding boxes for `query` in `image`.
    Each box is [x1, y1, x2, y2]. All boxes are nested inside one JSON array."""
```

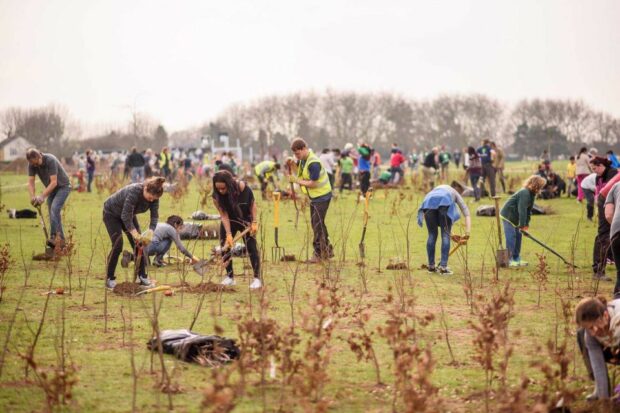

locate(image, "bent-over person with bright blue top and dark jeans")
[[418, 185, 471, 275]]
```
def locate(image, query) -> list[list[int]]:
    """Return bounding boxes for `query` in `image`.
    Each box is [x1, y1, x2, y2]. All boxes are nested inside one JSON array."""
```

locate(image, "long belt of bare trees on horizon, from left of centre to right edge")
[[199, 90, 620, 156]]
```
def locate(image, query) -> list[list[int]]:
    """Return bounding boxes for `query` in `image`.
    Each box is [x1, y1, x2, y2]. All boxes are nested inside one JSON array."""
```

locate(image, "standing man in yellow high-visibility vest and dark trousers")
[[289, 138, 334, 263]]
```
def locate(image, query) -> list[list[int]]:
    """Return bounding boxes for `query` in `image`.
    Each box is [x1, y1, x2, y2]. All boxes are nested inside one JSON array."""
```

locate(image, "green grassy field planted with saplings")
[[0, 164, 614, 412]]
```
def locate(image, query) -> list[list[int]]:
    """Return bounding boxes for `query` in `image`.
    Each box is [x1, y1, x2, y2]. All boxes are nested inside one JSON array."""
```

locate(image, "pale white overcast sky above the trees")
[[0, 0, 620, 131]]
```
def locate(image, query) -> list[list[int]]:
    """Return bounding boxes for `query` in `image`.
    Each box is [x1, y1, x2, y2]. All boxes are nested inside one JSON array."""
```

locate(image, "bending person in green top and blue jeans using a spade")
[[500, 175, 547, 268]]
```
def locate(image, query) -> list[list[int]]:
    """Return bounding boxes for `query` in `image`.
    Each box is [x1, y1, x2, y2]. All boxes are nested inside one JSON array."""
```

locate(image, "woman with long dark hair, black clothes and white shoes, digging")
[[213, 171, 263, 290]]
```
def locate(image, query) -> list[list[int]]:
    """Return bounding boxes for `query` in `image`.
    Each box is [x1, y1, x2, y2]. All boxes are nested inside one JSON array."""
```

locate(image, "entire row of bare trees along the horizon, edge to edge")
[[0, 90, 620, 156]]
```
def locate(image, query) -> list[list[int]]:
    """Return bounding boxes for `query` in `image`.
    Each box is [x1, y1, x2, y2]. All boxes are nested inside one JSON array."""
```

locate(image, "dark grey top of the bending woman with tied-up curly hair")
[[103, 184, 159, 231]]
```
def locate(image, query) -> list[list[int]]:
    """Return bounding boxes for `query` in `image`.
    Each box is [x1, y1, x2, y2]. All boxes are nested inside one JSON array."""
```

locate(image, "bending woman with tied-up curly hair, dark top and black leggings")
[[103, 177, 166, 288]]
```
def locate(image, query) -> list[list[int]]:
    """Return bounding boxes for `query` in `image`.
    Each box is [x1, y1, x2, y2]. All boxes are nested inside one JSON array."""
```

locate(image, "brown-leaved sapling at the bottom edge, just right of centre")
[[378, 293, 442, 412]]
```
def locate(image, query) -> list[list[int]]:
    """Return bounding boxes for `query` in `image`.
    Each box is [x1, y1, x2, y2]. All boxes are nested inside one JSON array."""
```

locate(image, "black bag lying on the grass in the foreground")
[[146, 329, 241, 367]]
